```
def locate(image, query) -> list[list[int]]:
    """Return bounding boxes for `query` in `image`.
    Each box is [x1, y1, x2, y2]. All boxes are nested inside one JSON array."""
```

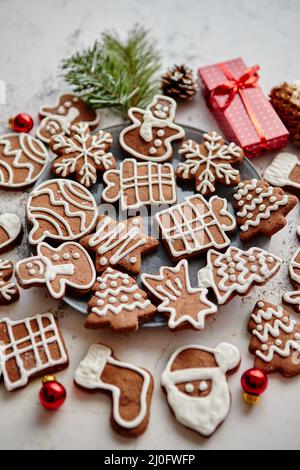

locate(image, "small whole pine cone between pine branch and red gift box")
[[161, 65, 198, 100]]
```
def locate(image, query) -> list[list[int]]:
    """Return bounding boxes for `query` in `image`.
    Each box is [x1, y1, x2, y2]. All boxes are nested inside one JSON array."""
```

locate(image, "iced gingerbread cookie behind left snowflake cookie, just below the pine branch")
[[36, 94, 99, 144]]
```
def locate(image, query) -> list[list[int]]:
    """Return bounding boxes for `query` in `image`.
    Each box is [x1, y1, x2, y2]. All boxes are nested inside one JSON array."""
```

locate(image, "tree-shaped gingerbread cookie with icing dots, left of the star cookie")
[[85, 268, 156, 332]]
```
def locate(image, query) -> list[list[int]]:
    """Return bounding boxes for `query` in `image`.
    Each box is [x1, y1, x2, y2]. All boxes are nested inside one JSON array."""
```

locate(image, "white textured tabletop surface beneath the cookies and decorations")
[[0, 0, 300, 449]]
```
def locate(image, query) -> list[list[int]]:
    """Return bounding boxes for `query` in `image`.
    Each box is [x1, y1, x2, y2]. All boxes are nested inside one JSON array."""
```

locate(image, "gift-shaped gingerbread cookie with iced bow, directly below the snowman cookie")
[[102, 158, 176, 210]]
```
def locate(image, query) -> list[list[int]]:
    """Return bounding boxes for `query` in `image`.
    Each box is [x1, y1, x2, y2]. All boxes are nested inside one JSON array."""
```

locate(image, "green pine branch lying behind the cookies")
[[62, 26, 160, 115]]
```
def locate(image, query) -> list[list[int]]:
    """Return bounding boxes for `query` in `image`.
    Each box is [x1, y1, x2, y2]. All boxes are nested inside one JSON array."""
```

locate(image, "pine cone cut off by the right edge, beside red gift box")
[[270, 81, 300, 146]]
